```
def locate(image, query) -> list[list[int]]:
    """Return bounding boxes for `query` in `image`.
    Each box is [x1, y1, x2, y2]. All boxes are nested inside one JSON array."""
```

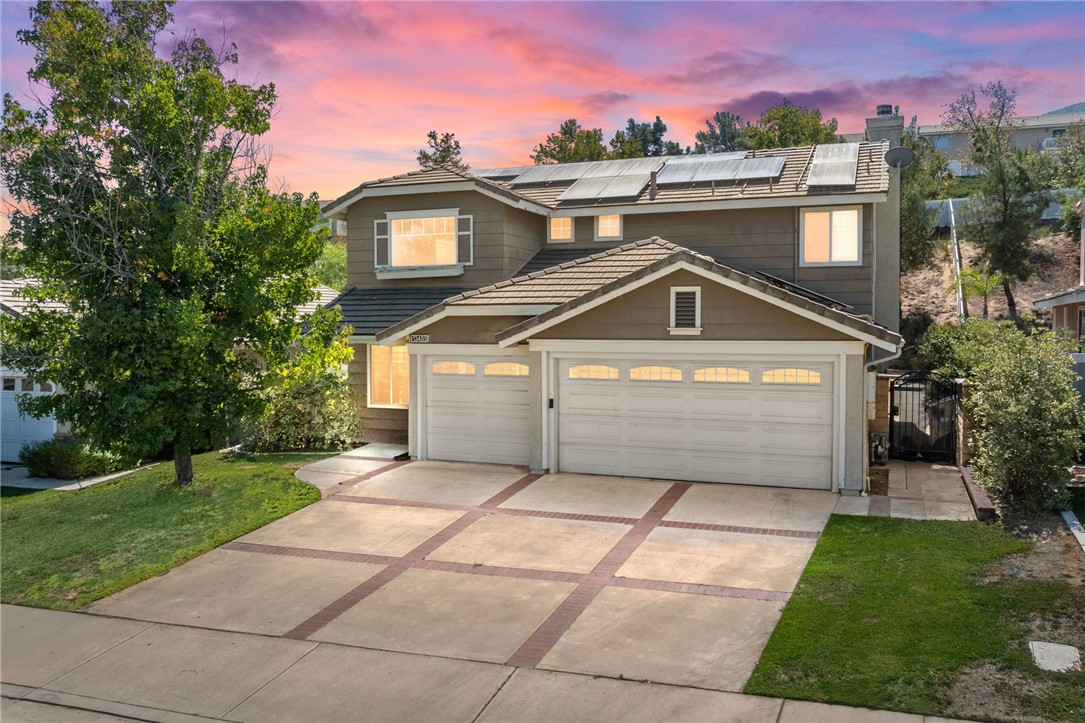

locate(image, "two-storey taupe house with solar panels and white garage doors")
[[326, 123, 903, 493]]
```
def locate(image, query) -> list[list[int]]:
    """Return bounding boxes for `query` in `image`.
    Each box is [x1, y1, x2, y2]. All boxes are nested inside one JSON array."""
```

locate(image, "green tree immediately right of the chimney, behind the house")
[[901, 118, 953, 272]]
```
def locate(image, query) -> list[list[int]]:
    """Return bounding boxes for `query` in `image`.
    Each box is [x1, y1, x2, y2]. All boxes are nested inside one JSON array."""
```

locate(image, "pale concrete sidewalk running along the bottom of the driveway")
[[0, 606, 967, 723]]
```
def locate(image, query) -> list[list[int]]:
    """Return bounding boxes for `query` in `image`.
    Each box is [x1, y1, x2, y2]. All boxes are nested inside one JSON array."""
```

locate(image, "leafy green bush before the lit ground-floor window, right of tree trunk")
[[244, 309, 361, 452]]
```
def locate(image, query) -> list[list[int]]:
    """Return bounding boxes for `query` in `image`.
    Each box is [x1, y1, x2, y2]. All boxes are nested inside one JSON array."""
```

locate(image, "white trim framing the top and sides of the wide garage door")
[[544, 349, 853, 489]]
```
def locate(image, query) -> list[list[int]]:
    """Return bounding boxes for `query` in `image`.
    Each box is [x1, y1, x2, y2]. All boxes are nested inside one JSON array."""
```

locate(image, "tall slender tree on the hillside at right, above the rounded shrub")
[[942, 83, 1049, 318]]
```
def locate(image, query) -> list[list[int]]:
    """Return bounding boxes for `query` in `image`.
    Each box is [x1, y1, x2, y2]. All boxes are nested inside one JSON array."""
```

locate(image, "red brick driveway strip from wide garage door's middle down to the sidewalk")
[[508, 482, 692, 668]]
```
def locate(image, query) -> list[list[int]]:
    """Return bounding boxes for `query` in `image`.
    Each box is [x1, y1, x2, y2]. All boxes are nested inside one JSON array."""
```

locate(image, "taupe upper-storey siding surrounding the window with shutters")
[[346, 191, 546, 289]]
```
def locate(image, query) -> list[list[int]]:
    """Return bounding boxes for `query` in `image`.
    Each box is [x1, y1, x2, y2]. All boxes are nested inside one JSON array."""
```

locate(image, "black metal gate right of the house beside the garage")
[[889, 371, 958, 462]]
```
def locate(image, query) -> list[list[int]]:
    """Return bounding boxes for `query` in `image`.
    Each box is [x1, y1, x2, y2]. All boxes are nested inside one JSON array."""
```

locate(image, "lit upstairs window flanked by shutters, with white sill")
[[373, 208, 474, 269]]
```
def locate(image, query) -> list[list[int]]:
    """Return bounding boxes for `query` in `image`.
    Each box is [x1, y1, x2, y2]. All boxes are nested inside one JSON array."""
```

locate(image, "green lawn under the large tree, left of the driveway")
[[0, 452, 330, 610]]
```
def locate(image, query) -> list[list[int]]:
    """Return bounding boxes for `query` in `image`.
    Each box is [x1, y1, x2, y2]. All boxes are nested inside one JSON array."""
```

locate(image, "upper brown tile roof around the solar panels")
[[324, 141, 889, 215]]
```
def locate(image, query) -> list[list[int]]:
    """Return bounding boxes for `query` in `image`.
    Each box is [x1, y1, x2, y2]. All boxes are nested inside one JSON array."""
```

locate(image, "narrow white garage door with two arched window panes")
[[425, 357, 532, 465]]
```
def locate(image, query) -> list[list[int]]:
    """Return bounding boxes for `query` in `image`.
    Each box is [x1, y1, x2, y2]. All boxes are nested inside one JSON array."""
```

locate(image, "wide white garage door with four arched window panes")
[[558, 359, 833, 490]]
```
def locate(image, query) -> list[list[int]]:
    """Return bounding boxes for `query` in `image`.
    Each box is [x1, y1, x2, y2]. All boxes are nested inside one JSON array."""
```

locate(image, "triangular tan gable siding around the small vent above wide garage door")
[[531, 270, 851, 341]]
